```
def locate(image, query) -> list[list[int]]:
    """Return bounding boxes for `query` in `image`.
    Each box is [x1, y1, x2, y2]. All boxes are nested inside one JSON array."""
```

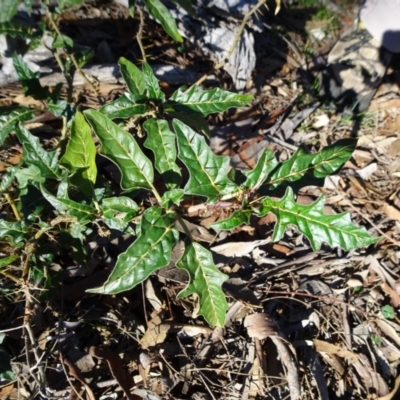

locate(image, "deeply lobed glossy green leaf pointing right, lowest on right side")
[[260, 187, 379, 251]]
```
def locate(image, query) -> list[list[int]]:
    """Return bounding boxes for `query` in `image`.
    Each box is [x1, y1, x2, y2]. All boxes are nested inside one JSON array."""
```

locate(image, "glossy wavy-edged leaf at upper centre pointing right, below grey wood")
[[166, 86, 253, 116]]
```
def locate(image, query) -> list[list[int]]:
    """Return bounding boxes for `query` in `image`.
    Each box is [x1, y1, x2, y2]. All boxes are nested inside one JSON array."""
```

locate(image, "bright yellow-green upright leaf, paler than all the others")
[[60, 111, 97, 195]]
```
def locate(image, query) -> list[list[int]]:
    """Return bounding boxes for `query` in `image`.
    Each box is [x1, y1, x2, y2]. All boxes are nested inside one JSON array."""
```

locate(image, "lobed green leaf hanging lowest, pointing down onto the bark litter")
[[176, 242, 228, 326]]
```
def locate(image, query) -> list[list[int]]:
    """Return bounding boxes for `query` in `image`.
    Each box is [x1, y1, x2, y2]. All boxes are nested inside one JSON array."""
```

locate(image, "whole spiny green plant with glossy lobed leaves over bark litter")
[[0, 58, 376, 326]]
